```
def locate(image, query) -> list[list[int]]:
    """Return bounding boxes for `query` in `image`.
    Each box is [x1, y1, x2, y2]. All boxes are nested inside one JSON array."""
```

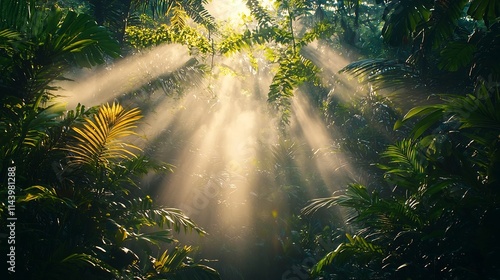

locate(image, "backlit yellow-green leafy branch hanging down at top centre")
[[236, 1, 338, 123]]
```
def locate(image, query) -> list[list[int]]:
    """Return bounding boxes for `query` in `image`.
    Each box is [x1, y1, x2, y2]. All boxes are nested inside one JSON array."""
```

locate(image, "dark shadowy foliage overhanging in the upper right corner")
[[344, 0, 500, 92]]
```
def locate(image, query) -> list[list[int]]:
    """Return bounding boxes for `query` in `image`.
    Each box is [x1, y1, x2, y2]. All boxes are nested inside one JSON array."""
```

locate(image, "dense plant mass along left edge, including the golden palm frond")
[[0, 1, 219, 279]]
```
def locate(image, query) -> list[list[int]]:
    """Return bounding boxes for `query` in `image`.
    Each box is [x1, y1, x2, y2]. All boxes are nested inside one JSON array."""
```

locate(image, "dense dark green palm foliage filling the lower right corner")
[[303, 87, 500, 279]]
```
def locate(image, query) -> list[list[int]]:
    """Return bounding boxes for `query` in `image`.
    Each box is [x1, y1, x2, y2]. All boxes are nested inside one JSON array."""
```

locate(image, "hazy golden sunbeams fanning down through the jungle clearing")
[[54, 23, 366, 277]]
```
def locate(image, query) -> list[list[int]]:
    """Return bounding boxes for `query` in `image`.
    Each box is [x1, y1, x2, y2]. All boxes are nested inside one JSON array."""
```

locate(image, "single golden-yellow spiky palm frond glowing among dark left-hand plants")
[[64, 103, 142, 167]]
